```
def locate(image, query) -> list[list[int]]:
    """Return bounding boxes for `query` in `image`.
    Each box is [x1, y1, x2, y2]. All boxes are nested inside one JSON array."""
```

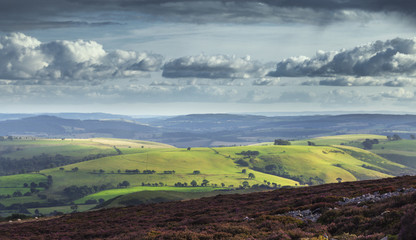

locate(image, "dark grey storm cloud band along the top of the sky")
[[0, 0, 416, 31]]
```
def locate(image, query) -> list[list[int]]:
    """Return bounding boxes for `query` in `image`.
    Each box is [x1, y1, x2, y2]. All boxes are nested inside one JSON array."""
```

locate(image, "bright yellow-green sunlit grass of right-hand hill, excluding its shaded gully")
[[216, 145, 398, 182]]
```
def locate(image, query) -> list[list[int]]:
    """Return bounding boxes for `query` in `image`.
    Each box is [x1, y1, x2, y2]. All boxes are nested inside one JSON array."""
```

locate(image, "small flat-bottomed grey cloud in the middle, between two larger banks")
[[162, 55, 268, 79]]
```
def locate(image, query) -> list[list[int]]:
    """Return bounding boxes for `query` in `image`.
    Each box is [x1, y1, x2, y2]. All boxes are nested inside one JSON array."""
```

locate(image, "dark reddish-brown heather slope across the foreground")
[[0, 176, 416, 240]]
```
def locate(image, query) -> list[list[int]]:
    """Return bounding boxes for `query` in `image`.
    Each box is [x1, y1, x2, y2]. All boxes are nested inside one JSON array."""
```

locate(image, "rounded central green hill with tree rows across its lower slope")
[[41, 148, 297, 198]]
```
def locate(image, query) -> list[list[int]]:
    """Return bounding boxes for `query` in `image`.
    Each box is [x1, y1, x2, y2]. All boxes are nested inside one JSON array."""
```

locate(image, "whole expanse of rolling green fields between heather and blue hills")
[[0, 135, 416, 216]]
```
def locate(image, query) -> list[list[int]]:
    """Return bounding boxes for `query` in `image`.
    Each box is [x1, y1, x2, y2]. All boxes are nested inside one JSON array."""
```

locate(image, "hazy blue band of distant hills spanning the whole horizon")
[[0, 113, 416, 147]]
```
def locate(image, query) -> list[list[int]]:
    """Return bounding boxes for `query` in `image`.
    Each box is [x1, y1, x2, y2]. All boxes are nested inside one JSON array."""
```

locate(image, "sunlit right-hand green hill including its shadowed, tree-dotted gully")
[[215, 146, 406, 184]]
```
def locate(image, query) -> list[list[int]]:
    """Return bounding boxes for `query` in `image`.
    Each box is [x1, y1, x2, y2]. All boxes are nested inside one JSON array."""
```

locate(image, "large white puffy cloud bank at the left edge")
[[0, 33, 163, 80]]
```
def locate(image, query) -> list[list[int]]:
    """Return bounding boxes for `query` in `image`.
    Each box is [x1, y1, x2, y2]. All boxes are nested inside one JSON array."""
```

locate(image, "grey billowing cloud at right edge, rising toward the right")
[[269, 38, 416, 77]]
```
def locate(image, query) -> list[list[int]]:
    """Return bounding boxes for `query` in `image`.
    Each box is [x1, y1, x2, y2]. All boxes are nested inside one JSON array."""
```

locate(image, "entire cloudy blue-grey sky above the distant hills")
[[0, 0, 416, 115]]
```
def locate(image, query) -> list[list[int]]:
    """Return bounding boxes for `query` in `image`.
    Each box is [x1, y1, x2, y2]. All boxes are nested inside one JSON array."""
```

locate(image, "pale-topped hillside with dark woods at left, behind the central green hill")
[[0, 137, 172, 176]]
